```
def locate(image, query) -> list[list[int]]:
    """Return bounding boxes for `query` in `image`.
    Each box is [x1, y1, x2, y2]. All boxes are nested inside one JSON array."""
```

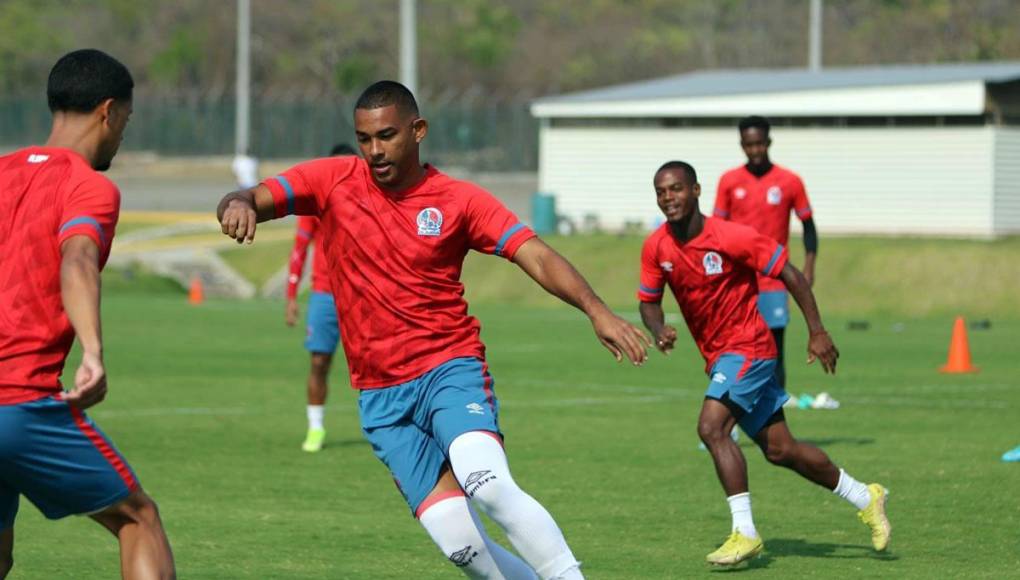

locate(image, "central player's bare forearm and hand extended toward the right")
[[513, 238, 652, 365]]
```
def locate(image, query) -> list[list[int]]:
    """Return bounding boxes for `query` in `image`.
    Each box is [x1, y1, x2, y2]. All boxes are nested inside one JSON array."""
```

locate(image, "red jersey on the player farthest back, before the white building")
[[714, 165, 811, 292]]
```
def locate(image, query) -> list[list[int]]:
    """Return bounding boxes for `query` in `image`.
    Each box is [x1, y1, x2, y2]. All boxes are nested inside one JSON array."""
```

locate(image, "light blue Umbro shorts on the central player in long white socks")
[[358, 357, 502, 516]]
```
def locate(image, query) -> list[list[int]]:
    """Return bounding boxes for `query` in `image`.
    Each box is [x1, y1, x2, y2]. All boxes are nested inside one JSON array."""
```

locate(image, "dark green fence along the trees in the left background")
[[0, 93, 539, 171]]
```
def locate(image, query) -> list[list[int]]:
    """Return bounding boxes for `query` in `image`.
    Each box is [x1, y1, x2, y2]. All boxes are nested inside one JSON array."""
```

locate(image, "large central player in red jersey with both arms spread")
[[217, 81, 650, 578]]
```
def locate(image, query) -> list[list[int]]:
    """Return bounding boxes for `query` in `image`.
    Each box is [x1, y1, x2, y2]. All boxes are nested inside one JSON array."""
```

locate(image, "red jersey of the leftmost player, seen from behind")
[[0, 147, 120, 405]]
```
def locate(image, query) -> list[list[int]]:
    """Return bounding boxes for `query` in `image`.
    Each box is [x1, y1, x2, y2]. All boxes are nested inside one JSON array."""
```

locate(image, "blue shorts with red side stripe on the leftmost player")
[[0, 397, 139, 530]]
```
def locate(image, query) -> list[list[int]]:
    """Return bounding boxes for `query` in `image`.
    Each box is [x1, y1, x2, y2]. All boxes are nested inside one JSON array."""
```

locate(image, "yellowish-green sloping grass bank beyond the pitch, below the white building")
[[213, 234, 1020, 318]]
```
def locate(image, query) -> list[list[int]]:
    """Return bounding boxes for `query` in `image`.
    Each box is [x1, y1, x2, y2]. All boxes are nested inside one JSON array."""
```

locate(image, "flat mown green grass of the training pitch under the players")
[[11, 295, 1020, 580]]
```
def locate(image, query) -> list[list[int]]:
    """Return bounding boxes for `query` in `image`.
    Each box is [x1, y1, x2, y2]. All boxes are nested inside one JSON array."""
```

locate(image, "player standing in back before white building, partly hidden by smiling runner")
[[713, 115, 818, 388]]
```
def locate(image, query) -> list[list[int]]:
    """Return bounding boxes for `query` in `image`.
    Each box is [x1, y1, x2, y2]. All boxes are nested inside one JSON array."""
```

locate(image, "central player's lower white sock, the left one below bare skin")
[[418, 495, 536, 580]]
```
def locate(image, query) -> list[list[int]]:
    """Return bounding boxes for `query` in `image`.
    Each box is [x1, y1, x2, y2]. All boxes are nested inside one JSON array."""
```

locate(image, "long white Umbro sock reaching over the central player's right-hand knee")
[[450, 431, 583, 580]]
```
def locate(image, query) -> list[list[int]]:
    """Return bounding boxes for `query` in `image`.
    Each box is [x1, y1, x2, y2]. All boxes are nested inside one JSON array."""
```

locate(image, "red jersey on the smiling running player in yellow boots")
[[638, 217, 786, 371]]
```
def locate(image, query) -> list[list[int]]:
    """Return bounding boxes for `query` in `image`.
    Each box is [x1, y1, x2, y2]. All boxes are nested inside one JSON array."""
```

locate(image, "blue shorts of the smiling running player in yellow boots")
[[705, 354, 789, 437]]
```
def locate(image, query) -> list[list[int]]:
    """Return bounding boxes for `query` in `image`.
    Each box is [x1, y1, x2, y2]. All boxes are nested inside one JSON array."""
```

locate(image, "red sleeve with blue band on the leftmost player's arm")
[[57, 174, 120, 268]]
